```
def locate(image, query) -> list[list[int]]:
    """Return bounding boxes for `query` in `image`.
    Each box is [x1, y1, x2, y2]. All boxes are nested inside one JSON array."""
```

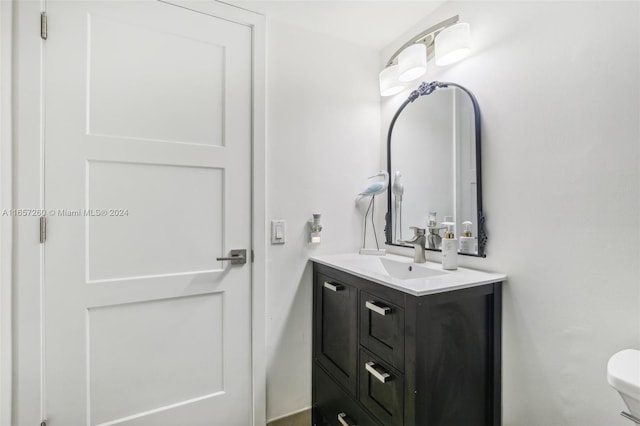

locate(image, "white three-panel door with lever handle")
[[43, 0, 252, 426]]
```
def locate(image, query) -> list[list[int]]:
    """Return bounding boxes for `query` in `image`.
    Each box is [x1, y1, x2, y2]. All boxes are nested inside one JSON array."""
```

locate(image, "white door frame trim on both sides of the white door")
[[0, 0, 267, 426]]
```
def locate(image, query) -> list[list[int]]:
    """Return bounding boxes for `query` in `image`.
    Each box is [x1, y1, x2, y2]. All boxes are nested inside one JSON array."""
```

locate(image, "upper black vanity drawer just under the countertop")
[[360, 291, 404, 371]]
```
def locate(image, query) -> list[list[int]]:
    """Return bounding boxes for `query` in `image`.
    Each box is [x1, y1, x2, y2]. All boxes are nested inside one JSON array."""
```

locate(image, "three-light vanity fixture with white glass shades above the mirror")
[[380, 15, 471, 96]]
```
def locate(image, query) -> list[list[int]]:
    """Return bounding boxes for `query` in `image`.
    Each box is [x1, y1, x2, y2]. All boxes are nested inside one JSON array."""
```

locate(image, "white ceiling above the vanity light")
[[226, 0, 446, 49]]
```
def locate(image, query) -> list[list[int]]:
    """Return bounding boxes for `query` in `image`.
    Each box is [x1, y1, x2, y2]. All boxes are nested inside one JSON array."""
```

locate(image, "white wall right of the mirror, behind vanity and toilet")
[[380, 1, 640, 426]]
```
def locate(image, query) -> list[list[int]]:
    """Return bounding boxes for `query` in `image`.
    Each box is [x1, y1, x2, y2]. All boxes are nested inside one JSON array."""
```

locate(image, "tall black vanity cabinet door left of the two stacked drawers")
[[314, 273, 358, 397]]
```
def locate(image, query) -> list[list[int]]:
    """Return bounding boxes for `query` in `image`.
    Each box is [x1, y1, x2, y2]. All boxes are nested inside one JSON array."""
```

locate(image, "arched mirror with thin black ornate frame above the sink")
[[386, 82, 486, 257]]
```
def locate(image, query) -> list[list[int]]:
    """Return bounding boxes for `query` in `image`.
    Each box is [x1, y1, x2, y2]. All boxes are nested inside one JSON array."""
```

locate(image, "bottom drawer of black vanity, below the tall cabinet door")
[[313, 367, 378, 426]]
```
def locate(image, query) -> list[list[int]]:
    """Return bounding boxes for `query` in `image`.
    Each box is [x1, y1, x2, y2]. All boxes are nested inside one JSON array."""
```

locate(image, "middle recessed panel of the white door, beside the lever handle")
[[86, 161, 224, 282]]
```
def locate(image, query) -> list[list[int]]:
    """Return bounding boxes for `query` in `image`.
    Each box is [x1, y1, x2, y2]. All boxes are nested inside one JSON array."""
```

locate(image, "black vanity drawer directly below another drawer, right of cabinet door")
[[359, 350, 404, 426]]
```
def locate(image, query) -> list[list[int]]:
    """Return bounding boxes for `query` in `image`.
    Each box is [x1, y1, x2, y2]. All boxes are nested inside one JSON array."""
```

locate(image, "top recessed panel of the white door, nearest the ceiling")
[[87, 11, 226, 146]]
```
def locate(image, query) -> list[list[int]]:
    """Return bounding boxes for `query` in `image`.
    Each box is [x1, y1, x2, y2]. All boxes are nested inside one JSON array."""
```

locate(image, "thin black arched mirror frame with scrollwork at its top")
[[385, 81, 487, 257]]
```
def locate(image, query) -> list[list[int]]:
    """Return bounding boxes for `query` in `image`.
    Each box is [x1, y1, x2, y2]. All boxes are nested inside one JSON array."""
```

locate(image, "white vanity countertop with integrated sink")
[[311, 253, 507, 296]]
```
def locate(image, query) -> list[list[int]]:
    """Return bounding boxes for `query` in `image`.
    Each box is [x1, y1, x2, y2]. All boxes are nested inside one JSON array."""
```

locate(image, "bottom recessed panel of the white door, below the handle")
[[87, 293, 224, 424]]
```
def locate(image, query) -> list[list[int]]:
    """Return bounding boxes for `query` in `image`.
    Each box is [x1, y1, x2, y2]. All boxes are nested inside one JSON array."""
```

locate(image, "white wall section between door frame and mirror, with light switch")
[[266, 20, 384, 419]]
